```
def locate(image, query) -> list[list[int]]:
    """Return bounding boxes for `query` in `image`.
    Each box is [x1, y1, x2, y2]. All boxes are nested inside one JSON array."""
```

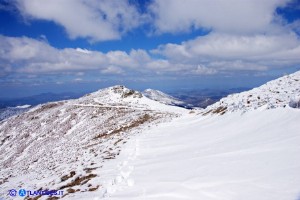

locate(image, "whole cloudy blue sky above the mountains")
[[0, 0, 300, 97]]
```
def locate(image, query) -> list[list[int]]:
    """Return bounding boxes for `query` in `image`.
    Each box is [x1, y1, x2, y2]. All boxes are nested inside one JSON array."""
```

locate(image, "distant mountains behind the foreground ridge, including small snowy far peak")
[[0, 88, 247, 109]]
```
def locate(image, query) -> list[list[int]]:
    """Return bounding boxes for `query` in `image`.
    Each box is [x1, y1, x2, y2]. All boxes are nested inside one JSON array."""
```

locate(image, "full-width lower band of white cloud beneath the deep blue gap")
[[0, 33, 300, 78]]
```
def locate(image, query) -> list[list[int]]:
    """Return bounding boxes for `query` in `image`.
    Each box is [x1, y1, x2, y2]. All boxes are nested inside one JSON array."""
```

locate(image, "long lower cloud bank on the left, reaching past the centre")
[[0, 35, 176, 76]]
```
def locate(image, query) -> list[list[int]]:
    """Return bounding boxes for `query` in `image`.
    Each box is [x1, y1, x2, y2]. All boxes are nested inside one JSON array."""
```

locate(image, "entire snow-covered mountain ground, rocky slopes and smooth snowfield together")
[[0, 72, 300, 200]]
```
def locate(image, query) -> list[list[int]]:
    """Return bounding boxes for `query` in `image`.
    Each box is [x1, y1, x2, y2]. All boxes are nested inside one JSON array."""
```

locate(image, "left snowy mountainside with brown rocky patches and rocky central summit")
[[0, 86, 187, 199]]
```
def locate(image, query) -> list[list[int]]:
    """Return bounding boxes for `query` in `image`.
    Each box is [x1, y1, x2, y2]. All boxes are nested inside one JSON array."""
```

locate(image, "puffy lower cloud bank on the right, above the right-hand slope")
[[152, 33, 300, 71]]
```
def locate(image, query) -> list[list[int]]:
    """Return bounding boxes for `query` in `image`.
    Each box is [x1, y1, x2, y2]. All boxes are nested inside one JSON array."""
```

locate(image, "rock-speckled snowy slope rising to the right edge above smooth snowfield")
[[204, 71, 300, 114]]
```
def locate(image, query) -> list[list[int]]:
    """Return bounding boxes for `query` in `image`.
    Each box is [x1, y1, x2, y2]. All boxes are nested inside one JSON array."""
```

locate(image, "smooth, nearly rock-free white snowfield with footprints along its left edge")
[[103, 108, 300, 200]]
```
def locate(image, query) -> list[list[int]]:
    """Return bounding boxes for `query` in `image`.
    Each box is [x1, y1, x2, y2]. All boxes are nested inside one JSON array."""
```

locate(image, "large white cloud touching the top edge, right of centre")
[[150, 0, 290, 34]]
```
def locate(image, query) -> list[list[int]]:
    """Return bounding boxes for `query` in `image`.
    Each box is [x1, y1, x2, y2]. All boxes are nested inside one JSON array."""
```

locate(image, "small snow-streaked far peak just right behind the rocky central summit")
[[142, 89, 191, 107]]
